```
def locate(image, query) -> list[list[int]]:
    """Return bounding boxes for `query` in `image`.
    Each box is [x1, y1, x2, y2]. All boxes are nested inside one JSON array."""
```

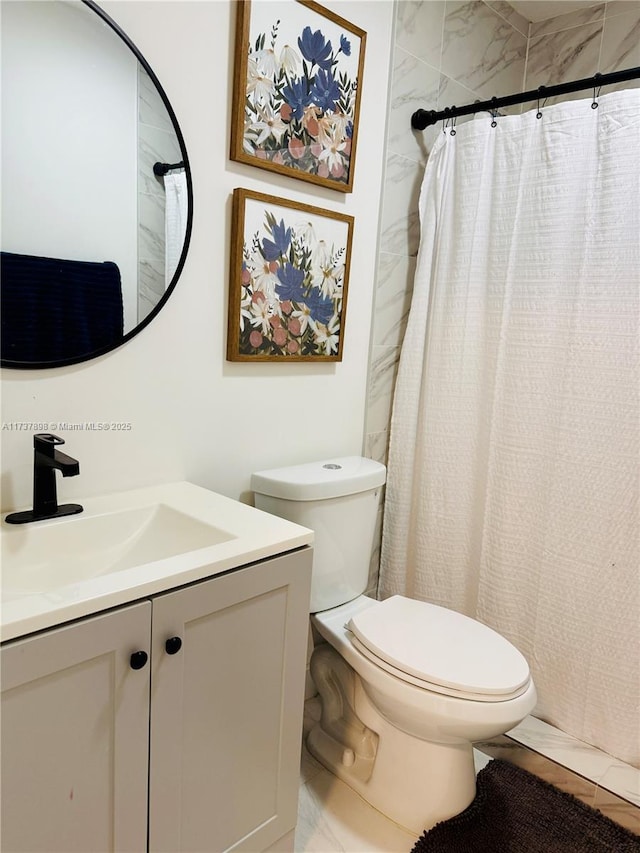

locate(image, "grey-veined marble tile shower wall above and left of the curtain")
[[364, 0, 640, 593]]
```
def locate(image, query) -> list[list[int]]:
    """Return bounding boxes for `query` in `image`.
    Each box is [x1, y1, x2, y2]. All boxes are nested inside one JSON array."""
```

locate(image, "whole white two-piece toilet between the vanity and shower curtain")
[[251, 456, 536, 835]]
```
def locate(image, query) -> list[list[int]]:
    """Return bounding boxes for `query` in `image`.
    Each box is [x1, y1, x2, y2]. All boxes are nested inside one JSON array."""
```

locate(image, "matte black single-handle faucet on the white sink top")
[[5, 432, 82, 524]]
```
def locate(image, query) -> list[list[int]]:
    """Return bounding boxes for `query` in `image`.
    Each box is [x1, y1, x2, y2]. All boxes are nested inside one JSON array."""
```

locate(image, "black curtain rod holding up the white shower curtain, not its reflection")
[[411, 68, 640, 130]]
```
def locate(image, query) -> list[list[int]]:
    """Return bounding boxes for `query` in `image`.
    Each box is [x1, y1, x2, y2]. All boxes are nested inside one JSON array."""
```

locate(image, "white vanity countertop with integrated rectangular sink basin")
[[0, 483, 313, 641]]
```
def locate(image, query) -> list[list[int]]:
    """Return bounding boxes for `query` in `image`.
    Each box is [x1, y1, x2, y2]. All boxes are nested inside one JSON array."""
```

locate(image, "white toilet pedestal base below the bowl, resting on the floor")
[[307, 643, 476, 836]]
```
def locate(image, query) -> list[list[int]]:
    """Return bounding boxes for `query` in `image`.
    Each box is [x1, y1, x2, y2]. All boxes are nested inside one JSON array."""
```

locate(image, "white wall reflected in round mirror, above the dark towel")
[[2, 2, 138, 330]]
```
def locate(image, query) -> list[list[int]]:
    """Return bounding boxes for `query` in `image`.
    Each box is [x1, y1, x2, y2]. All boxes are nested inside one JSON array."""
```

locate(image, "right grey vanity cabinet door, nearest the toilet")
[[149, 549, 311, 853]]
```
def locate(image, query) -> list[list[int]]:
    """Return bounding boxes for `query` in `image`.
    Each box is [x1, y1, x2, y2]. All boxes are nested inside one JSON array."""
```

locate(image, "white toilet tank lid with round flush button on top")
[[251, 456, 387, 501]]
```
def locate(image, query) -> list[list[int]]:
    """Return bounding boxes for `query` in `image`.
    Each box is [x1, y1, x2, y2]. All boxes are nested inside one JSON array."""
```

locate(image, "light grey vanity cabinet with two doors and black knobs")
[[0, 548, 311, 853]]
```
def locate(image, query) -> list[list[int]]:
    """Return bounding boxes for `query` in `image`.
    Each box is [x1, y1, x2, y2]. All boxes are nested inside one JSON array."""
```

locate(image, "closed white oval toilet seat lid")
[[347, 595, 530, 701]]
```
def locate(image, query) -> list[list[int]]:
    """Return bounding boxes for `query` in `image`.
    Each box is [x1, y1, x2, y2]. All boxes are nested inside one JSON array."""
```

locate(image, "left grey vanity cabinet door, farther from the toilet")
[[1, 602, 151, 853]]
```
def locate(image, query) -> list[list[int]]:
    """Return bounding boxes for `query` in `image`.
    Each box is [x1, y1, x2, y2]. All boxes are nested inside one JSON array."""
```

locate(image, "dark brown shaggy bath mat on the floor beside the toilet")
[[411, 759, 640, 853]]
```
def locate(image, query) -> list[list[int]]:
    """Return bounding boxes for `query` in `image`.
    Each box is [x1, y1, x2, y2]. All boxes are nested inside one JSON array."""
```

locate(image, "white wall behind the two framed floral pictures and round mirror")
[[1, 0, 393, 510]]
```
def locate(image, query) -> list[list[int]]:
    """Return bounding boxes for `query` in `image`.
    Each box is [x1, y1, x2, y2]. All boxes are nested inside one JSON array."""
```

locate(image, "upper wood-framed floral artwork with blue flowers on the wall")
[[231, 0, 366, 192]]
